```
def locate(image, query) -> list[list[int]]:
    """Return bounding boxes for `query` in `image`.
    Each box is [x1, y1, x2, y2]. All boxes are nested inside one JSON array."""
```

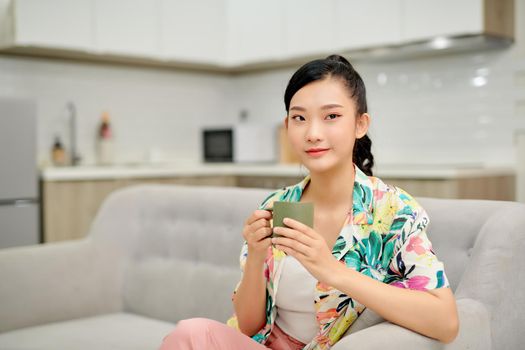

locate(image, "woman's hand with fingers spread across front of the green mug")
[[272, 218, 339, 282]]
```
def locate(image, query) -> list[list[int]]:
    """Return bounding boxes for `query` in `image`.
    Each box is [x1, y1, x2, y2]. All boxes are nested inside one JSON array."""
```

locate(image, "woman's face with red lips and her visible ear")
[[285, 78, 370, 172]]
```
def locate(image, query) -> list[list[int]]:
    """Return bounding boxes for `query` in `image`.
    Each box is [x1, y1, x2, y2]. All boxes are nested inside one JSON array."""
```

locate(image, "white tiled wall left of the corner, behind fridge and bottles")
[[0, 56, 233, 164]]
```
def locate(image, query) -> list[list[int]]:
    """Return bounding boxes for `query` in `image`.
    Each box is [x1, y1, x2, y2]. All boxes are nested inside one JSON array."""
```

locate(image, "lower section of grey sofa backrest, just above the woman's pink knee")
[[124, 257, 240, 322]]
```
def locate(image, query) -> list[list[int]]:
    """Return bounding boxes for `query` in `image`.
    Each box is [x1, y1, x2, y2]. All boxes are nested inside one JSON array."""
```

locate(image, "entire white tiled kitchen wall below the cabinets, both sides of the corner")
[[0, 0, 525, 165]]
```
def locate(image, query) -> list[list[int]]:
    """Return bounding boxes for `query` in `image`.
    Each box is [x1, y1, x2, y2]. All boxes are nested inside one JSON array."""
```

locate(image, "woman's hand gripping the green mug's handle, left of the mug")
[[242, 209, 272, 261]]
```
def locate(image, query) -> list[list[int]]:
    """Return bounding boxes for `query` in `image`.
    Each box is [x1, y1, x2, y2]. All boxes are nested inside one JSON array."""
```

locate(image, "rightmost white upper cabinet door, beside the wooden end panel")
[[401, 0, 487, 42]]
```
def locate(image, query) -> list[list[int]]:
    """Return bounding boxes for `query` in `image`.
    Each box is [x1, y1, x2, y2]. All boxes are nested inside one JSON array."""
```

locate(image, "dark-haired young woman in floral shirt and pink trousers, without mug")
[[161, 55, 459, 350]]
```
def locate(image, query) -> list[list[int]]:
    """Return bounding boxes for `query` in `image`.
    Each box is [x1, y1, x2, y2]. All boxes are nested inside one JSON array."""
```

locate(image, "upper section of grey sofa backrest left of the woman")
[[90, 185, 271, 267]]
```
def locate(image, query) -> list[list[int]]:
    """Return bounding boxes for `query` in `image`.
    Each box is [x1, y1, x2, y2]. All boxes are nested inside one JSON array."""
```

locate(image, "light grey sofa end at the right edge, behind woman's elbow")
[[454, 202, 525, 349]]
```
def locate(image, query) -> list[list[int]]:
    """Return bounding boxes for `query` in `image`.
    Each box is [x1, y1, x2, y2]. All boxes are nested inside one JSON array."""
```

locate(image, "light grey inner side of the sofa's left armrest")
[[0, 238, 121, 332]]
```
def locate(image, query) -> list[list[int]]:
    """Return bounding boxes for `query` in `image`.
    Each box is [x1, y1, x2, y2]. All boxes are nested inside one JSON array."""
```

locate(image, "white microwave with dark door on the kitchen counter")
[[202, 123, 277, 163]]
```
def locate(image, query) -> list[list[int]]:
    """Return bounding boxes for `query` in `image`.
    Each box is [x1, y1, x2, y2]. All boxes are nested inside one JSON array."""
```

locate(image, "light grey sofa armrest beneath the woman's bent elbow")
[[332, 299, 491, 350]]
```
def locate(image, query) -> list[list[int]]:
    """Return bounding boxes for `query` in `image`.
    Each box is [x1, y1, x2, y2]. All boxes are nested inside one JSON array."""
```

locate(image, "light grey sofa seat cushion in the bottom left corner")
[[0, 313, 175, 350]]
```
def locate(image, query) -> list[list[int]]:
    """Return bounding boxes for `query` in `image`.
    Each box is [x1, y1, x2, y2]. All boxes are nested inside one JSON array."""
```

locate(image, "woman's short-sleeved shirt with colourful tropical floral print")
[[227, 164, 449, 350]]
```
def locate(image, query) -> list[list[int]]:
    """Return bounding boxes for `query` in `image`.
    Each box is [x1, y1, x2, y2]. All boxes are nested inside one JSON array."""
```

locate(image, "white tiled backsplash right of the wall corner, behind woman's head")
[[226, 49, 524, 165]]
